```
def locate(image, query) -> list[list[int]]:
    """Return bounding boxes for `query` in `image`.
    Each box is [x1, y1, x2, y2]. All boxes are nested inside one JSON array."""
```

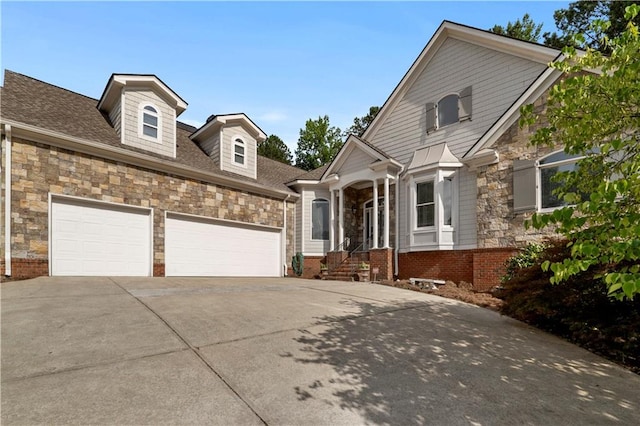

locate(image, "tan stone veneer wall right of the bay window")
[[476, 93, 559, 248]]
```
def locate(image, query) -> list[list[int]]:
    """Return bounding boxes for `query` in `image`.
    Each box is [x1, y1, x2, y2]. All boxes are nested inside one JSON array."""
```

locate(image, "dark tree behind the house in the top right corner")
[[543, 0, 640, 52]]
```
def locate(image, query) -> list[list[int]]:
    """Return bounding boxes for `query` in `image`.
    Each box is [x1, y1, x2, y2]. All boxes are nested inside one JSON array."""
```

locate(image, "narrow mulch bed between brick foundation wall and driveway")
[[380, 280, 503, 312]]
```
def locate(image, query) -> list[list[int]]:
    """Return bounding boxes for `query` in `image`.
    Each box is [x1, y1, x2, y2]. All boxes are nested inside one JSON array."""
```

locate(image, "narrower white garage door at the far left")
[[51, 197, 152, 276]]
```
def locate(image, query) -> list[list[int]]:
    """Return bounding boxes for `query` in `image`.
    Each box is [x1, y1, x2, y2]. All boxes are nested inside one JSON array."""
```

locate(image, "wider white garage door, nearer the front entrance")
[[165, 214, 281, 277]]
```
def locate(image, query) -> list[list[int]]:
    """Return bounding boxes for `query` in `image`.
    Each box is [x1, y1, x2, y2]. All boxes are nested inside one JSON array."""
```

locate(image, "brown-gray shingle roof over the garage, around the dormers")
[[0, 70, 304, 193]]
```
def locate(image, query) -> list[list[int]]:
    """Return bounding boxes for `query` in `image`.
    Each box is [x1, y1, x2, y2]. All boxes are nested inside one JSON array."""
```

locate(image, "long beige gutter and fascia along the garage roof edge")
[[2, 119, 299, 199]]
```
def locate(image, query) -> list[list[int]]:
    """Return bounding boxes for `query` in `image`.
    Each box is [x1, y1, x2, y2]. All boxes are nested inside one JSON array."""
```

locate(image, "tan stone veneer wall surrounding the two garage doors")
[[0, 138, 295, 278]]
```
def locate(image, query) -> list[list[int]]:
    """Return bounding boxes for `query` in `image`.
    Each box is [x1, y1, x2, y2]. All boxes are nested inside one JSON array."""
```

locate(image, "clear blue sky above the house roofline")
[[0, 1, 568, 152]]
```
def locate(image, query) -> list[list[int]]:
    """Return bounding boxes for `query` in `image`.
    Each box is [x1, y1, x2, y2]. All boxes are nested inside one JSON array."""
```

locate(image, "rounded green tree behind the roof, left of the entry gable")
[[296, 115, 342, 170]]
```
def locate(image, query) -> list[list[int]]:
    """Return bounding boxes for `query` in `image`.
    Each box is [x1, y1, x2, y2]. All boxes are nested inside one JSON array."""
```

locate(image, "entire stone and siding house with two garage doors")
[[0, 21, 575, 289]]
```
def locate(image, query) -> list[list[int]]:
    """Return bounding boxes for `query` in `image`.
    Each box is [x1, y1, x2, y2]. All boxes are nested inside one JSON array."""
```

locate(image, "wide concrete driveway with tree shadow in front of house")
[[0, 278, 640, 425]]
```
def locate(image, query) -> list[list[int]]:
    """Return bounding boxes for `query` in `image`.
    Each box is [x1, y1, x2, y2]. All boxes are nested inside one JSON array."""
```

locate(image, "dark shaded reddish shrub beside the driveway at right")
[[499, 241, 640, 373]]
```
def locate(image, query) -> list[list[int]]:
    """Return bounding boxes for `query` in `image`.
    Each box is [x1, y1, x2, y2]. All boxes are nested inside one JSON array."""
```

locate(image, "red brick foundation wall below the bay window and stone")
[[398, 247, 517, 291]]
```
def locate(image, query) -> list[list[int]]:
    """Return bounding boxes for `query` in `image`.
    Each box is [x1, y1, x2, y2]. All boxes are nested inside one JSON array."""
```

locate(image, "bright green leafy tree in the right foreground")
[[521, 5, 640, 299]]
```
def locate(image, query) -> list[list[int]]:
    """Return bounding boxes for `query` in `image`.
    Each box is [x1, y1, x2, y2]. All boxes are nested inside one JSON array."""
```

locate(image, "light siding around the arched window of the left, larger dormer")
[[121, 89, 176, 157]]
